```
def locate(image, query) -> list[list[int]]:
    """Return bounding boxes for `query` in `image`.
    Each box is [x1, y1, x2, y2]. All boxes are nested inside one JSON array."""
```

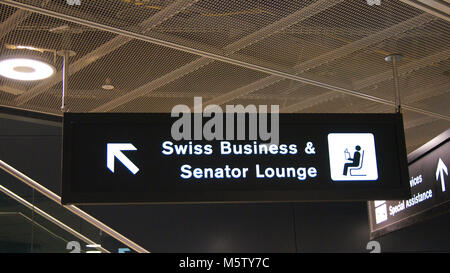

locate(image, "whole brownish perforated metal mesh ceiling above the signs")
[[0, 0, 450, 150]]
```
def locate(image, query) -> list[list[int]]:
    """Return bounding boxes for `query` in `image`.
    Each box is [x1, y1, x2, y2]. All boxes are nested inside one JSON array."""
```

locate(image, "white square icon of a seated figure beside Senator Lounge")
[[328, 133, 378, 181]]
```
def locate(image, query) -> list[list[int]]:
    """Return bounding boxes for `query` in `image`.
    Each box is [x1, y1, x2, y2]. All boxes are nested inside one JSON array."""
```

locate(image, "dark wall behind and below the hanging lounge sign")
[[0, 118, 450, 252]]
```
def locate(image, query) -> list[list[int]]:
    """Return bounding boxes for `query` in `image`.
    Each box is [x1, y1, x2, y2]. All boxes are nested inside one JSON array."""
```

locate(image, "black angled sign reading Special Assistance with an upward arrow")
[[368, 129, 450, 238]]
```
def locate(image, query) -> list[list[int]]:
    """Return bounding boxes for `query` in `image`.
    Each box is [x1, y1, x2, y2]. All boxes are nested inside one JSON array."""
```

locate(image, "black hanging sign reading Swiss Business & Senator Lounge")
[[62, 113, 409, 204]]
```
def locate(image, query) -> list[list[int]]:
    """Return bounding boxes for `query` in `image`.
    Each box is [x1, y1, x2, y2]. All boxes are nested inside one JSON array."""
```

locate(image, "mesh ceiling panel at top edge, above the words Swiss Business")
[[151, 0, 313, 49]]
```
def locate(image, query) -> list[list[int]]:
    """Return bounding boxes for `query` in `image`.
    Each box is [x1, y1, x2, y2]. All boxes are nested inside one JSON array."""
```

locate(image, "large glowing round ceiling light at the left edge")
[[0, 58, 56, 81]]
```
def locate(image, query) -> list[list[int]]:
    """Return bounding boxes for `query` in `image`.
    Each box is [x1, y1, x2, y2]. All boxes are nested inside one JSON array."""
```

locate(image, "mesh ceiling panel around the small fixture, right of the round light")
[[47, 40, 198, 112]]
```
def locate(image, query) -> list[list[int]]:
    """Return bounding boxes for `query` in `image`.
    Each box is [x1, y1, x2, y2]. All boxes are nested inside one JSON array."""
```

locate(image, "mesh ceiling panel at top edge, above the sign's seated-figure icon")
[[232, 1, 421, 70]]
